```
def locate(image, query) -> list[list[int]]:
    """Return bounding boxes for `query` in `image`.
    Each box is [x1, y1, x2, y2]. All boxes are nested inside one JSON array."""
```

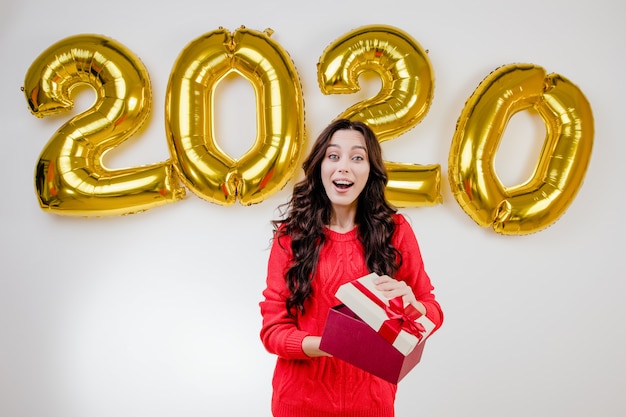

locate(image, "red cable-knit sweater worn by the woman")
[[260, 214, 443, 417]]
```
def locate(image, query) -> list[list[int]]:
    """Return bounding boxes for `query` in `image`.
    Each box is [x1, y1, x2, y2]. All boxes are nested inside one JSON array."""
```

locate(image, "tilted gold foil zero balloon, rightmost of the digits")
[[448, 64, 594, 235]]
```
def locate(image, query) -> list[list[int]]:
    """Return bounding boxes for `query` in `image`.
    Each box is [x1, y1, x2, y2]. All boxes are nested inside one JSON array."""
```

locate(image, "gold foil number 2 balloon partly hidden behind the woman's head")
[[317, 25, 442, 206]]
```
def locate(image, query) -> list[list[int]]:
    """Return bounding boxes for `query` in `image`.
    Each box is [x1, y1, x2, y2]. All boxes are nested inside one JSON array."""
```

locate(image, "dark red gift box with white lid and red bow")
[[320, 274, 435, 383]]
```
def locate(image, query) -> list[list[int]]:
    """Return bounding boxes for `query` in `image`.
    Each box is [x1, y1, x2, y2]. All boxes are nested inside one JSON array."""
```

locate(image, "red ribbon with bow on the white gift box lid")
[[352, 281, 426, 344]]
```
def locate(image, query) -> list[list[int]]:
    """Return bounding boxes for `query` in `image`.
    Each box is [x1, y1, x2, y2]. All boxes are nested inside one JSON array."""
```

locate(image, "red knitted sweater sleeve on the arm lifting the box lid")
[[394, 214, 443, 333]]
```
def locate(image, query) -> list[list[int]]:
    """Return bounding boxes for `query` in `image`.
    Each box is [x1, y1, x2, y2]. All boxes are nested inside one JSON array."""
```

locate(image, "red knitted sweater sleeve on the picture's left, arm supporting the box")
[[259, 232, 309, 359]]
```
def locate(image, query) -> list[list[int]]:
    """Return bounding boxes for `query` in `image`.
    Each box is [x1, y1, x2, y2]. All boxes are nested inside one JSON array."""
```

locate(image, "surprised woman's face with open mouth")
[[321, 129, 370, 208]]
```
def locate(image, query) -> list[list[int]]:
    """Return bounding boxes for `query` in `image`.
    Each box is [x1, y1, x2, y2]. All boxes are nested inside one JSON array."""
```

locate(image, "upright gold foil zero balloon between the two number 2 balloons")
[[165, 26, 305, 205]]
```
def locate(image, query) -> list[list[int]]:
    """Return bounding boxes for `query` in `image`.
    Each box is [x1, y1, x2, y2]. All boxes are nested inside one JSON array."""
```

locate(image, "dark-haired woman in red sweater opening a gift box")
[[260, 119, 443, 417]]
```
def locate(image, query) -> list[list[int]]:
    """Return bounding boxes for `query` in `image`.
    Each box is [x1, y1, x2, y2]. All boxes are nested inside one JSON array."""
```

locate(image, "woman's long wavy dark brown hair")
[[272, 119, 402, 316]]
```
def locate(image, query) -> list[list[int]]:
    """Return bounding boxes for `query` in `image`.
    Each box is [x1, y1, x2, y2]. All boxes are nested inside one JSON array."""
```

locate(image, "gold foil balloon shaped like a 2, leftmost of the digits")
[[23, 35, 185, 216]]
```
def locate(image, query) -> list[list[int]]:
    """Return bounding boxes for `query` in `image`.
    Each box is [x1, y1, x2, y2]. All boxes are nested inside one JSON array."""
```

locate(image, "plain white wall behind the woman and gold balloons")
[[0, 0, 626, 417]]
